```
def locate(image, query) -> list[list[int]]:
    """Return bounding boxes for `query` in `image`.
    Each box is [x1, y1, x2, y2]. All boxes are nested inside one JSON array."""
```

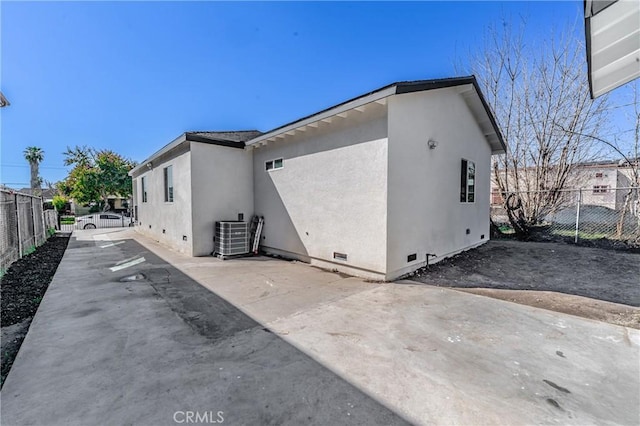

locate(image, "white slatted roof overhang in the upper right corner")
[[585, 0, 640, 98]]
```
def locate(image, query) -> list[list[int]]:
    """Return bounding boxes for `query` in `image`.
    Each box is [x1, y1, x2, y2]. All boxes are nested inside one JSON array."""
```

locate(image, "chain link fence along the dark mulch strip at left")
[[0, 190, 57, 272]]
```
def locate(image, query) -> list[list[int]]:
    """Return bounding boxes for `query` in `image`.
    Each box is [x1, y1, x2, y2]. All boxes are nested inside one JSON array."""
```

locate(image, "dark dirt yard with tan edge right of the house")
[[409, 240, 640, 329]]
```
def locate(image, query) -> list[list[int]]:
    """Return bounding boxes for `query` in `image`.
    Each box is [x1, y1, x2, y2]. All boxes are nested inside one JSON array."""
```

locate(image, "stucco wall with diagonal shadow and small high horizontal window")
[[253, 106, 387, 277]]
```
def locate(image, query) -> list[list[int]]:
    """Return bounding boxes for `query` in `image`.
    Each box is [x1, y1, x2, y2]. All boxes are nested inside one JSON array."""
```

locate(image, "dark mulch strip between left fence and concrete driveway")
[[0, 234, 69, 386]]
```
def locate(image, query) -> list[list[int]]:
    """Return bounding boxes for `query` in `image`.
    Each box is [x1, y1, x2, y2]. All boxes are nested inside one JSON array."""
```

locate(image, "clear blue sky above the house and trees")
[[0, 1, 636, 187]]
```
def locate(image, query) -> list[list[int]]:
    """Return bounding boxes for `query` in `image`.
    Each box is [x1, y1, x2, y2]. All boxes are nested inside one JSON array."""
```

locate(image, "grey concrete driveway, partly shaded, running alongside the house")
[[1, 230, 640, 425]]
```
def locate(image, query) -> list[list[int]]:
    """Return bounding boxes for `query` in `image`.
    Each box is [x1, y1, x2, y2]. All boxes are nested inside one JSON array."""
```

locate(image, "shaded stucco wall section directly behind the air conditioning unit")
[[191, 142, 253, 256]]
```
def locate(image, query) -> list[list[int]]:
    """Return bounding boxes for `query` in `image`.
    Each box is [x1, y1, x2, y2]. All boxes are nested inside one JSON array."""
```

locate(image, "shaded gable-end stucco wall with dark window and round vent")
[[387, 88, 491, 279]]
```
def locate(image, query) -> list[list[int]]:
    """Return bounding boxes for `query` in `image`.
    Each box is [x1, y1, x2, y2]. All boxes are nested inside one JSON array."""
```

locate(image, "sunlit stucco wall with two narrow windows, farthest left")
[[134, 152, 193, 255]]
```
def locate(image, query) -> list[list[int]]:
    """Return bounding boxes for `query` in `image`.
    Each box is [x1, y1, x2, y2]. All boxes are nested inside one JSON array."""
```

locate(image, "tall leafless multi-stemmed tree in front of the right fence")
[[471, 23, 607, 239]]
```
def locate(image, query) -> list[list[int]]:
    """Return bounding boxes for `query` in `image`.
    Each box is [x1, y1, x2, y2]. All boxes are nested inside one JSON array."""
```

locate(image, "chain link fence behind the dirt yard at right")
[[491, 186, 640, 246]]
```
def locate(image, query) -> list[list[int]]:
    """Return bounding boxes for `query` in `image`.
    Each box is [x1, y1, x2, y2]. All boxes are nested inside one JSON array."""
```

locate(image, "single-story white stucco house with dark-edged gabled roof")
[[130, 77, 506, 280]]
